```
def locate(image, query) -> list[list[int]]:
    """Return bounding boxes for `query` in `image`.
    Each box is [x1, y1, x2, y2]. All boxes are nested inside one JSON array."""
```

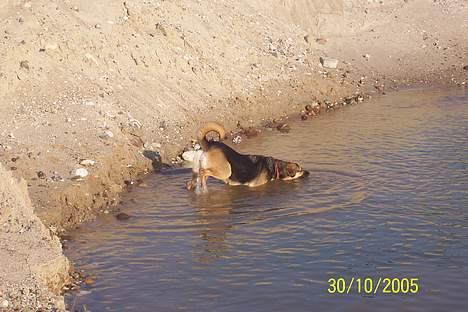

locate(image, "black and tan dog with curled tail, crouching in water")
[[187, 122, 309, 193]]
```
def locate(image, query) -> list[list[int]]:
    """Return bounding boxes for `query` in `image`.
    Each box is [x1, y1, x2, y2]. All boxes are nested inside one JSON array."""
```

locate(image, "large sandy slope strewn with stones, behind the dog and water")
[[0, 0, 468, 309]]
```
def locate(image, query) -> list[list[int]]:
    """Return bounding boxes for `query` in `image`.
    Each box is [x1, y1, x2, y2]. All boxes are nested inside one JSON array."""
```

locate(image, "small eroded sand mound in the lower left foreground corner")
[[0, 165, 69, 311]]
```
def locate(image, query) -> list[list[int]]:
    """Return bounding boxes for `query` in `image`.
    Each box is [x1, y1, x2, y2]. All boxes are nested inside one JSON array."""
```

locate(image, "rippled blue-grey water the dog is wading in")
[[66, 90, 468, 311]]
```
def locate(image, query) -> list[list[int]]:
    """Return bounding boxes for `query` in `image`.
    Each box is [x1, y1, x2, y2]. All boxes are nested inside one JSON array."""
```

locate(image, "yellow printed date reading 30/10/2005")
[[327, 277, 419, 295]]
